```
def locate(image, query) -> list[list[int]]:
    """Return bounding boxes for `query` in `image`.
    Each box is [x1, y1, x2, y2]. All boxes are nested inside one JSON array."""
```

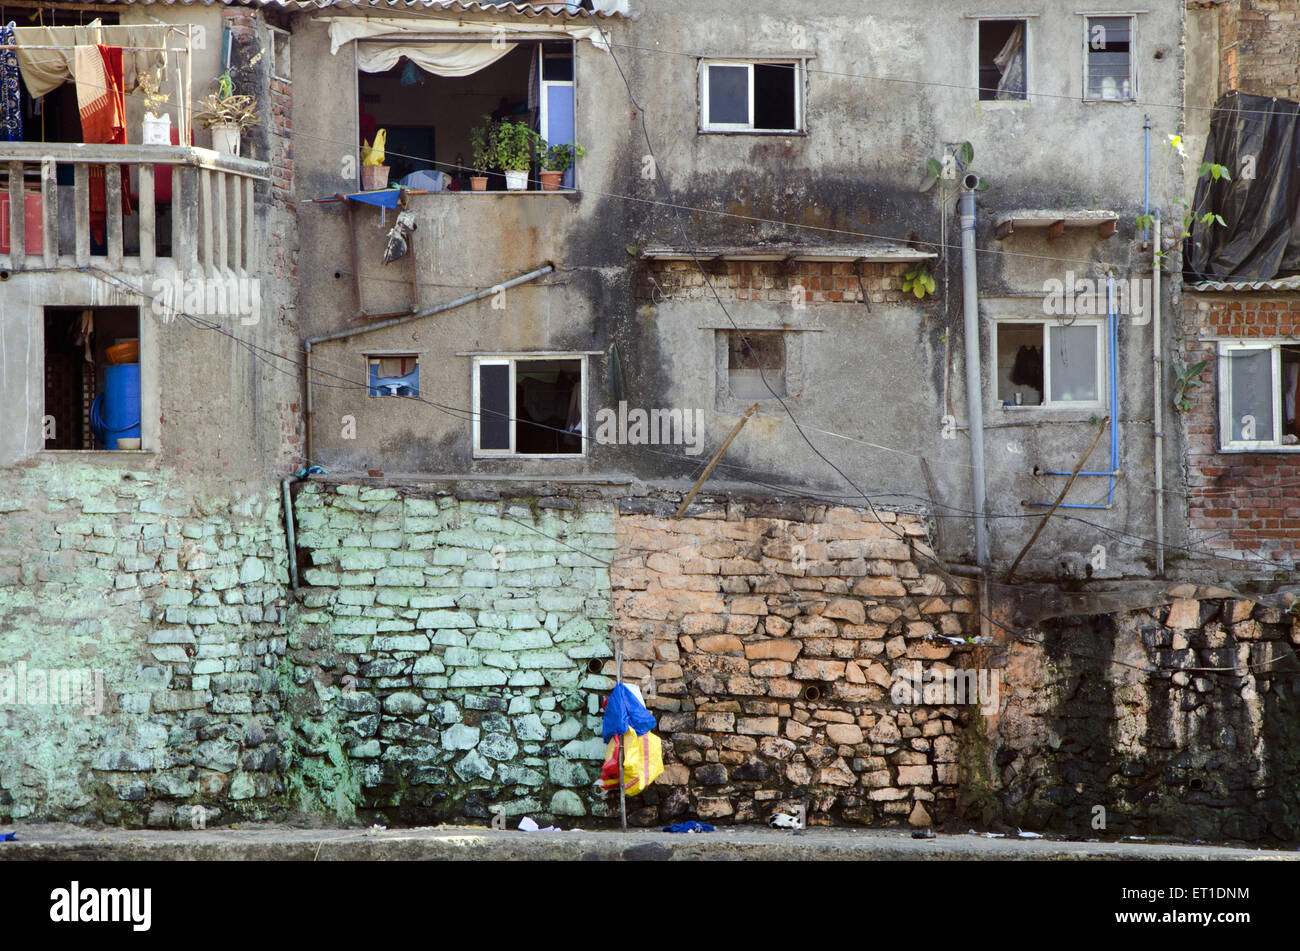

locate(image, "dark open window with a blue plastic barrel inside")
[[42, 307, 147, 451]]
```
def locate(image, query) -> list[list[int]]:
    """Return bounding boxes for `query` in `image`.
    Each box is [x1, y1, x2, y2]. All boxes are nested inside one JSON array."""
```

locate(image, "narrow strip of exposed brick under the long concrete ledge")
[[637, 261, 913, 304]]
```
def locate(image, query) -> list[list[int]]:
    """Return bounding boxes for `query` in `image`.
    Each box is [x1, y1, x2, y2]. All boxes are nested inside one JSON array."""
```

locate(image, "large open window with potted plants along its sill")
[[358, 39, 576, 191]]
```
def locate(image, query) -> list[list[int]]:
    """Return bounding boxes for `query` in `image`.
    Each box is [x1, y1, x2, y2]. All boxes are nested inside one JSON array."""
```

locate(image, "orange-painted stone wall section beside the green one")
[[610, 501, 978, 824]]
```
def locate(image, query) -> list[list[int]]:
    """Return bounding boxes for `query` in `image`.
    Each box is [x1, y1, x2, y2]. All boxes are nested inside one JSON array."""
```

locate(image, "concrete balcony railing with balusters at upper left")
[[0, 142, 269, 277]]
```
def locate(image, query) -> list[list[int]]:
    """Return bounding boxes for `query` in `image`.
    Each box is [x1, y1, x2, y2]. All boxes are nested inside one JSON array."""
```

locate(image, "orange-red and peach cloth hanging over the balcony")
[[73, 45, 131, 243]]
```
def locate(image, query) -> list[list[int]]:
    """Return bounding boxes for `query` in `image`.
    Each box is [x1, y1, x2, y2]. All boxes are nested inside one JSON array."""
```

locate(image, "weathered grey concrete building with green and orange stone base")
[[0, 0, 1300, 841]]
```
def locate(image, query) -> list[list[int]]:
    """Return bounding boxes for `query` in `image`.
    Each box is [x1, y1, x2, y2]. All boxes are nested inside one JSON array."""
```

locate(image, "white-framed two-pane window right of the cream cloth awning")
[[699, 60, 805, 135]]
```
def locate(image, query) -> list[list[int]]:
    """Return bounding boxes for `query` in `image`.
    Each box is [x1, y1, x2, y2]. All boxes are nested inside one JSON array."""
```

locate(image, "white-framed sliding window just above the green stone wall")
[[471, 353, 588, 459]]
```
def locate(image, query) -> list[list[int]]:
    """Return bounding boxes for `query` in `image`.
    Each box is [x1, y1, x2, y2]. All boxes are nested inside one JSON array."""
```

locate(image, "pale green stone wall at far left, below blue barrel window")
[[0, 461, 289, 826]]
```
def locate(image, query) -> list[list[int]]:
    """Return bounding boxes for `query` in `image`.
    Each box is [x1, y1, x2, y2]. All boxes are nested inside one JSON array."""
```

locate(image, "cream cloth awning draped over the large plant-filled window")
[[329, 17, 608, 77]]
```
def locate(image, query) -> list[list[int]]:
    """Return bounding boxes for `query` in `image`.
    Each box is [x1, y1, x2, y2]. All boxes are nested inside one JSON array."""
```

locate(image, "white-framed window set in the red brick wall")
[[1218, 340, 1300, 452]]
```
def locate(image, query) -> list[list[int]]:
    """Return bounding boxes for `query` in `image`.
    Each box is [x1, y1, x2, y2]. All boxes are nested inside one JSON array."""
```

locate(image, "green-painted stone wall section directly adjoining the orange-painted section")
[[289, 482, 616, 825]]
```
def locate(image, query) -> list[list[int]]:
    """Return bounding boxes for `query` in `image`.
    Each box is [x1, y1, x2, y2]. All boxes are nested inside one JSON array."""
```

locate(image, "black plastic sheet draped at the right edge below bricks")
[[1183, 92, 1300, 283]]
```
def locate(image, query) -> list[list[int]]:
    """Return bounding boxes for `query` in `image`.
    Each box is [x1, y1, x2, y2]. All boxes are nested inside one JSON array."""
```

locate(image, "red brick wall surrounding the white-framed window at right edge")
[[1175, 294, 1300, 565]]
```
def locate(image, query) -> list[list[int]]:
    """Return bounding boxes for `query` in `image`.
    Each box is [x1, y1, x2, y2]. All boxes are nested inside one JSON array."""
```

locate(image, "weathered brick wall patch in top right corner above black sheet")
[[1219, 0, 1300, 99]]
